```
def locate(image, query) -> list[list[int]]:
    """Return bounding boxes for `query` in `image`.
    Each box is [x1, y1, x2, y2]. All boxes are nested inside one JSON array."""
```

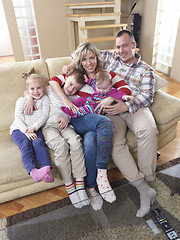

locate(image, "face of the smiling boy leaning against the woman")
[[63, 76, 82, 96]]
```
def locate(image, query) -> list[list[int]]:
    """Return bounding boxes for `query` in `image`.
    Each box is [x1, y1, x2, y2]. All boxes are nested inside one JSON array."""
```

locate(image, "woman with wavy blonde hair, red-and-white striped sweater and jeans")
[[49, 42, 130, 210]]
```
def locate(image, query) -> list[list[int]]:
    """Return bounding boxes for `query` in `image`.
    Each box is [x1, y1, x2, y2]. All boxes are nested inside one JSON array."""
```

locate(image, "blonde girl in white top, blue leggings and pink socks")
[[10, 69, 54, 183]]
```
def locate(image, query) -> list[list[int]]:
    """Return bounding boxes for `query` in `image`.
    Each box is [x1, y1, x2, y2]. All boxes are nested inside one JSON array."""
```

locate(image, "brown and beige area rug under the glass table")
[[0, 158, 180, 240]]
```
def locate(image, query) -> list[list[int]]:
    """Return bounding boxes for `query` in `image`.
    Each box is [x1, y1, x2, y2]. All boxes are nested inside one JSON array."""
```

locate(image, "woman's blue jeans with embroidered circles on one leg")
[[71, 113, 114, 188]]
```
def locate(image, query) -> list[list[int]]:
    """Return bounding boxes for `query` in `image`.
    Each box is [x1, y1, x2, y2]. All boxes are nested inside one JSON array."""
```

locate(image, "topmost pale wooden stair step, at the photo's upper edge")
[[65, 1, 114, 9]]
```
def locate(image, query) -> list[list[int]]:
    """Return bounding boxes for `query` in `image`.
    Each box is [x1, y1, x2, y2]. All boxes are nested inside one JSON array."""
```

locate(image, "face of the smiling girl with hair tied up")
[[27, 81, 45, 99]]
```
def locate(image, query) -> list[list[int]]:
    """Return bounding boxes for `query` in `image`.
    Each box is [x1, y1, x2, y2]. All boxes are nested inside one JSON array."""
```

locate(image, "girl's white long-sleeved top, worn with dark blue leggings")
[[10, 95, 50, 134]]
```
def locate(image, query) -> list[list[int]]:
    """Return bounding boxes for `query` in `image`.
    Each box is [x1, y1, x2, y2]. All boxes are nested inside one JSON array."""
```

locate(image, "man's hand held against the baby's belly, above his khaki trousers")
[[103, 101, 129, 115]]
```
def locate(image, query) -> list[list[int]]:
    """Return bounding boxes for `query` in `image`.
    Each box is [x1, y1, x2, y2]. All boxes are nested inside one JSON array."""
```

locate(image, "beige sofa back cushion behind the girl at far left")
[[0, 59, 49, 131]]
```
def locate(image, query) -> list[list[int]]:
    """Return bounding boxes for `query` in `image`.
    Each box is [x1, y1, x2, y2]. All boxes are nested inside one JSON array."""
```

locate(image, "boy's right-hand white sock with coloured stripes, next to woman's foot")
[[76, 178, 90, 206]]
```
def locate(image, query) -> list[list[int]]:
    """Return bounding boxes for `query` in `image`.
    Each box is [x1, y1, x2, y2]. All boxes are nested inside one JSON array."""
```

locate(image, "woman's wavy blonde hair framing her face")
[[74, 42, 103, 74]]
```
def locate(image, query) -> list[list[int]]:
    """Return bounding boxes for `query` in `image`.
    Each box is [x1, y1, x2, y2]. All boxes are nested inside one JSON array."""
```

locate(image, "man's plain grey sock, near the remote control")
[[136, 181, 156, 217]]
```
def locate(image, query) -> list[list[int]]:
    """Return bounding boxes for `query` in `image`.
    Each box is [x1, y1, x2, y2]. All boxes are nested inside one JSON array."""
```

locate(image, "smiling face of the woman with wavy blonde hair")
[[81, 50, 97, 74]]
